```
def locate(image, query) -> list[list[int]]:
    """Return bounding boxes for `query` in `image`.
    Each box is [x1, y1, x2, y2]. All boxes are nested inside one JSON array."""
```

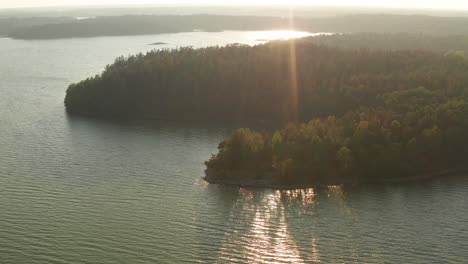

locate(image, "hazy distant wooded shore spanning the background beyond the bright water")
[[9, 15, 468, 39]]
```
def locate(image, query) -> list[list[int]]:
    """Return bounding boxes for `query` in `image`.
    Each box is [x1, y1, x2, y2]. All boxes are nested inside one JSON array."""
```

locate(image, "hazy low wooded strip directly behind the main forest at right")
[[308, 33, 468, 56]]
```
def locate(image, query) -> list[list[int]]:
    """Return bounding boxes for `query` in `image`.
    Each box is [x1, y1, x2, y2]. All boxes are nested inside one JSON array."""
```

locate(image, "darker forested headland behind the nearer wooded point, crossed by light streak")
[[65, 40, 468, 122]]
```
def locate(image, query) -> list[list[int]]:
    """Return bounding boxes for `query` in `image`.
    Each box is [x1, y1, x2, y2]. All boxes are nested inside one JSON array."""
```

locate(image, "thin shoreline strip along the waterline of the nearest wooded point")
[[203, 168, 468, 190]]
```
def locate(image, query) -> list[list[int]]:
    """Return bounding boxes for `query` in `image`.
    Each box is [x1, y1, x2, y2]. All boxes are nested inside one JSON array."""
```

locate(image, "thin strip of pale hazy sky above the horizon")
[[0, 0, 468, 10]]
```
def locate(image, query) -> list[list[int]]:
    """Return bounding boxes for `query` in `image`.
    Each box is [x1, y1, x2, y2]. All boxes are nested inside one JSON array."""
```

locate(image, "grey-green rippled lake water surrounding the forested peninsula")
[[0, 32, 468, 264]]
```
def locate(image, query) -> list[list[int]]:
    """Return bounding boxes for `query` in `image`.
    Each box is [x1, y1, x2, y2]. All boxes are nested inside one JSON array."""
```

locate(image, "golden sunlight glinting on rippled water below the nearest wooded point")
[[218, 189, 321, 264]]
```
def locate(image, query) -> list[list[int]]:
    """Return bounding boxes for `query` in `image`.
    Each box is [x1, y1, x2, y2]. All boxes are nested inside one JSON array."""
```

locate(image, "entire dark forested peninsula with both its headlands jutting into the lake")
[[65, 35, 468, 188]]
